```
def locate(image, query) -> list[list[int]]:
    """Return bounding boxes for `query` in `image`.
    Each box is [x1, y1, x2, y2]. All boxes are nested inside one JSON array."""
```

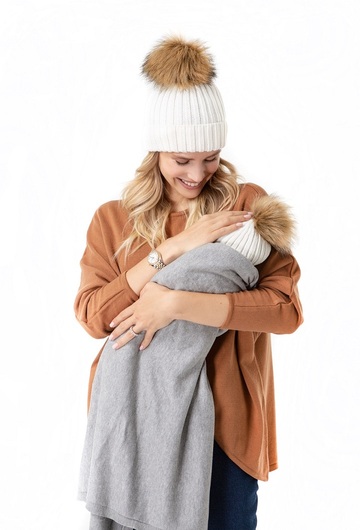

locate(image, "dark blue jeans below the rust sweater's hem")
[[208, 442, 258, 530]]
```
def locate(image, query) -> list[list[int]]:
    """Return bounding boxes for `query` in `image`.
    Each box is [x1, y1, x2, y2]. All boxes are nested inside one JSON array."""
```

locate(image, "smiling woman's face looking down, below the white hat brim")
[[159, 149, 220, 211]]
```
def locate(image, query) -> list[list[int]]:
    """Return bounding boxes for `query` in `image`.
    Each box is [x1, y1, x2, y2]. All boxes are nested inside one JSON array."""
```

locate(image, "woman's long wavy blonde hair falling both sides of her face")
[[116, 151, 240, 254]]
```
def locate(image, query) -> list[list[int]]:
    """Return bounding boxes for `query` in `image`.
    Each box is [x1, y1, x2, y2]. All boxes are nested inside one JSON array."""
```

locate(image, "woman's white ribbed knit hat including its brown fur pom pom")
[[143, 38, 227, 152]]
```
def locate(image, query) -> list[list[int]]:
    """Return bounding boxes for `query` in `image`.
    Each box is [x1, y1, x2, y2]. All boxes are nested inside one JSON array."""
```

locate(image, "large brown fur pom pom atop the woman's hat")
[[142, 37, 216, 90]]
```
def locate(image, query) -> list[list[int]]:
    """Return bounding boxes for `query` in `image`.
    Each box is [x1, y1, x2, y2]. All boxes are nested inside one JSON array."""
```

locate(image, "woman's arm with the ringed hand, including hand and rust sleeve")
[[110, 251, 303, 349]]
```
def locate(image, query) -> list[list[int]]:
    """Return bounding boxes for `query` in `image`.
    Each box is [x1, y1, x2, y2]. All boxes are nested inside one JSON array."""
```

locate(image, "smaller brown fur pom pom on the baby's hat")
[[251, 195, 296, 254]]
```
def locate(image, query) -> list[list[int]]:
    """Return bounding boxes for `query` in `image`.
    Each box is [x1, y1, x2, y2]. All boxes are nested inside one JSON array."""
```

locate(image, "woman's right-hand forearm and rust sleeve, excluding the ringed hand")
[[169, 251, 303, 334]]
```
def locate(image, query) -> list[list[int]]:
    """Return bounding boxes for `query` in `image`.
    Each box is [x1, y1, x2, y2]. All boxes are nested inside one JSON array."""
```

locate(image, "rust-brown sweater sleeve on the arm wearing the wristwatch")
[[74, 202, 138, 339]]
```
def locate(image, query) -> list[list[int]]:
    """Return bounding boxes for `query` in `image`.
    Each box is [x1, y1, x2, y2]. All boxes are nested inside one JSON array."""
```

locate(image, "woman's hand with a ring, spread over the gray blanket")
[[109, 282, 173, 350]]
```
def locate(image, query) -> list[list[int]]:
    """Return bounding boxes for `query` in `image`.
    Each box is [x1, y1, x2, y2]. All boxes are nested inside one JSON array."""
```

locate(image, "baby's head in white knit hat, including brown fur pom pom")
[[218, 195, 295, 265]]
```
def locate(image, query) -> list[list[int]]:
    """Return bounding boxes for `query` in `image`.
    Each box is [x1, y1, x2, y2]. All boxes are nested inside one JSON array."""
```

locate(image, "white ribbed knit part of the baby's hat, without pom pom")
[[218, 219, 271, 265]]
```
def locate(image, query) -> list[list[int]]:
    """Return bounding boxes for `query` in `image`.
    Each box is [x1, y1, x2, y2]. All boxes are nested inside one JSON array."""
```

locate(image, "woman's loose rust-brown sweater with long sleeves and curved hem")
[[75, 183, 303, 480]]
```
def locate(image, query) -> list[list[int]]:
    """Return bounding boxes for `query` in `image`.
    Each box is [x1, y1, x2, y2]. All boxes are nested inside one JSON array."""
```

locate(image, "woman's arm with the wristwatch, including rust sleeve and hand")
[[74, 201, 249, 338]]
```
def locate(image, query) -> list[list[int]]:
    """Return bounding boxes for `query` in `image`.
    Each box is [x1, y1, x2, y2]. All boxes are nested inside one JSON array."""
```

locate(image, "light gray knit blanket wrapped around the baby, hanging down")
[[79, 243, 258, 530]]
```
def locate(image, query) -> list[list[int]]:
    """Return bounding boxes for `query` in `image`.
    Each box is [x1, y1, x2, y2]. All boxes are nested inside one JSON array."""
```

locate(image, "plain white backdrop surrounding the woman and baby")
[[0, 0, 360, 530]]
